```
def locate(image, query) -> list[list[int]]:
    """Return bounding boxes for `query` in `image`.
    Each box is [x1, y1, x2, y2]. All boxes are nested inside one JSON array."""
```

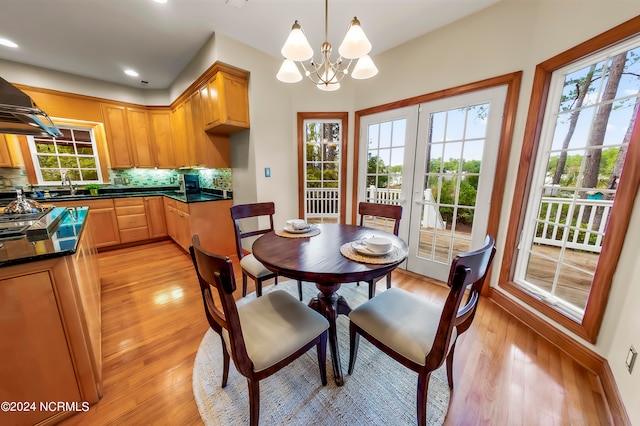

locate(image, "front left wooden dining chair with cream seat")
[[189, 234, 329, 425]]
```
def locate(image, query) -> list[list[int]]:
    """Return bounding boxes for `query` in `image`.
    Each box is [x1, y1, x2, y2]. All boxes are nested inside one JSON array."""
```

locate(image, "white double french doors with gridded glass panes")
[[358, 86, 507, 281]]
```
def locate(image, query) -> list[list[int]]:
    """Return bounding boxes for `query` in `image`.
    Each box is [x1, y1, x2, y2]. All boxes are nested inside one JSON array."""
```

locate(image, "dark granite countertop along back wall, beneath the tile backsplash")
[[0, 188, 233, 205]]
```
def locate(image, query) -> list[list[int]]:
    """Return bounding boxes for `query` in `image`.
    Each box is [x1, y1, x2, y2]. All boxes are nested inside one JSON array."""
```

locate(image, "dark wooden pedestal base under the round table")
[[309, 283, 351, 386]]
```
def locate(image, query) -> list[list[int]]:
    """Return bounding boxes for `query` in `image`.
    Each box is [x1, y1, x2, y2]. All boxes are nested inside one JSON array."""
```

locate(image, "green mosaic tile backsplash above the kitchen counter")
[[0, 168, 232, 191]]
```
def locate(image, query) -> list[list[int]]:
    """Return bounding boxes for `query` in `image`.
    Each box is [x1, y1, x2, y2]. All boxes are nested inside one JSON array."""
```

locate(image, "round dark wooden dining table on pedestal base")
[[252, 224, 408, 386]]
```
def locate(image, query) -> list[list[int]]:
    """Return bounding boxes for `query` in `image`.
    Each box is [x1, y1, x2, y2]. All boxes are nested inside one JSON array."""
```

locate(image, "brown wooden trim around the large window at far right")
[[499, 16, 640, 343]]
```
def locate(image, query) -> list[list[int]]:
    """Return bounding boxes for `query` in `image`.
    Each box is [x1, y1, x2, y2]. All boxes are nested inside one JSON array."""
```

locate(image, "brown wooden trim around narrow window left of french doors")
[[298, 112, 349, 223]]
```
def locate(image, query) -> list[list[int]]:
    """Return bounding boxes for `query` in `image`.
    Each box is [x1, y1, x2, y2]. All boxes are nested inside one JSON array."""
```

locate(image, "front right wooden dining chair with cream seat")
[[349, 236, 496, 425]]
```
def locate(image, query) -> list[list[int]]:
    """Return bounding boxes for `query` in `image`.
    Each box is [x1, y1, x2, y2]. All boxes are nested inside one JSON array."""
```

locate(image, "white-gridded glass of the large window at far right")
[[515, 42, 640, 320]]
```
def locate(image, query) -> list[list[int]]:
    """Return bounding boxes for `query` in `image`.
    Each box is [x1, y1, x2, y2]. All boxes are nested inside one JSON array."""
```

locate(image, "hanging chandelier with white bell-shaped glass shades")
[[276, 0, 378, 92]]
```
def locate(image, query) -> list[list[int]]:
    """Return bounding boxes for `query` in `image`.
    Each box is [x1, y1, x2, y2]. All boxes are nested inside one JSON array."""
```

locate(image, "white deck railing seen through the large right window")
[[533, 197, 613, 253]]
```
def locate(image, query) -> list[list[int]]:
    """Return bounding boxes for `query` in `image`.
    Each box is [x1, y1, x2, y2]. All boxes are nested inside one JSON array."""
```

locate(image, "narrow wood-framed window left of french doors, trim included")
[[298, 113, 347, 223]]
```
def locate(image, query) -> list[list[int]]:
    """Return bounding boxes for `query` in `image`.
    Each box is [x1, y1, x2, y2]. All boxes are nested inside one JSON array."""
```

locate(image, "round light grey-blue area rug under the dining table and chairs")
[[193, 281, 449, 426]]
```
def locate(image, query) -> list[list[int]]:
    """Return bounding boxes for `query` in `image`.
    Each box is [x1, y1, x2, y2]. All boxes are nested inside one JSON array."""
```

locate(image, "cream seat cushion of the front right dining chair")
[[349, 288, 457, 365]]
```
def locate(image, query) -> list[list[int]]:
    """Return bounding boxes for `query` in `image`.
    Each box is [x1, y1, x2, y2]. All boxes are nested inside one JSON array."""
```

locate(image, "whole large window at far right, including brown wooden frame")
[[500, 21, 640, 342]]
